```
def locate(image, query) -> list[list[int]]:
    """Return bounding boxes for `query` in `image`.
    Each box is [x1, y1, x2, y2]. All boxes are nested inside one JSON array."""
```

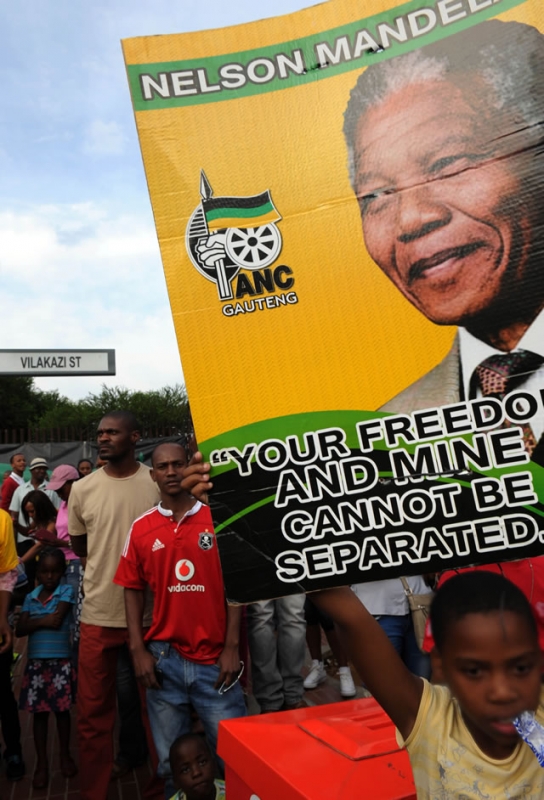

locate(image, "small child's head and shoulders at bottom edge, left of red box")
[[170, 733, 225, 800]]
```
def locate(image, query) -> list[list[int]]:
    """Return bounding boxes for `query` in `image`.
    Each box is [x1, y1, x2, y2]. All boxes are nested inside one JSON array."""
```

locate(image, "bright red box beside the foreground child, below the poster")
[[218, 699, 416, 800]]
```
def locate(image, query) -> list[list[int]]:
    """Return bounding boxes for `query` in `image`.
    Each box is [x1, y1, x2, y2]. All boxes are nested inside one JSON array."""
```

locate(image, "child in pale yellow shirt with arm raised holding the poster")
[[312, 572, 544, 800]]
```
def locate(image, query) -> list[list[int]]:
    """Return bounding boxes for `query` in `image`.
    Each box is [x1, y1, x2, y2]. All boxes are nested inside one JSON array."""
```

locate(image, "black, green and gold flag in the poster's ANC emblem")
[[202, 191, 281, 233]]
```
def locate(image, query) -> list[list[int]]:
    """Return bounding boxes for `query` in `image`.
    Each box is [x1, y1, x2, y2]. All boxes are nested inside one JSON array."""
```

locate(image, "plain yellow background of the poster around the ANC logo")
[[123, 0, 544, 441]]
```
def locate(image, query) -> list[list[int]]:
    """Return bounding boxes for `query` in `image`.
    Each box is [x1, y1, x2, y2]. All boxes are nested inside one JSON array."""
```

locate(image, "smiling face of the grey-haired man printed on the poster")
[[355, 80, 537, 325]]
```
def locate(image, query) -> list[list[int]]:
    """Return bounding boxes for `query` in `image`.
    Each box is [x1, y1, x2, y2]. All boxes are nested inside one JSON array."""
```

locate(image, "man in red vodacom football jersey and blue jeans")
[[114, 443, 246, 796]]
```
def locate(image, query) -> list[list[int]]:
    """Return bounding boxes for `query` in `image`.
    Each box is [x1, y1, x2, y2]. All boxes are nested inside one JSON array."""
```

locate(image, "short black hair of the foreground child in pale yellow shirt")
[[431, 570, 538, 652]]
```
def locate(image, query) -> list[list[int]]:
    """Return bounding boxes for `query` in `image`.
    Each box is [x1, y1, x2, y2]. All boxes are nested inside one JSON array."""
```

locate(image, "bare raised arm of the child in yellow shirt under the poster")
[[311, 587, 423, 739]]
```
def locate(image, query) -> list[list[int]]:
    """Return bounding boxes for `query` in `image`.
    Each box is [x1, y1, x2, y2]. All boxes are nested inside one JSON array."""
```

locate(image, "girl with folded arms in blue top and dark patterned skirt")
[[16, 548, 77, 789]]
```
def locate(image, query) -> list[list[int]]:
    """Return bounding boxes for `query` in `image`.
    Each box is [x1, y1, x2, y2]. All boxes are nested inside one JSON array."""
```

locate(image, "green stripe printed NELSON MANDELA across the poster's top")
[[127, 0, 527, 111]]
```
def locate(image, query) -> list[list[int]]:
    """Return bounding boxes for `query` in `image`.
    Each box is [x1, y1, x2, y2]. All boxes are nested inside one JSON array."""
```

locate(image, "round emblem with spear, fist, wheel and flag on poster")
[[186, 171, 282, 301]]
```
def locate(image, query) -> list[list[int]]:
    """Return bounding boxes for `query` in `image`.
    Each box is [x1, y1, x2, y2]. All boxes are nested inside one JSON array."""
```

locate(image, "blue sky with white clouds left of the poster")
[[0, 0, 313, 399]]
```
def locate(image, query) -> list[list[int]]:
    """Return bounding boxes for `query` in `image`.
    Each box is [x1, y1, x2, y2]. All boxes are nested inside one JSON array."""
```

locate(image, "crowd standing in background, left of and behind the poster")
[[0, 411, 362, 800]]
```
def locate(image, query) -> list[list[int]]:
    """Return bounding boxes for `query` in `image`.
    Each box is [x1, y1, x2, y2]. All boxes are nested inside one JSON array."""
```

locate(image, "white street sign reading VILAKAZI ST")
[[0, 350, 115, 377]]
